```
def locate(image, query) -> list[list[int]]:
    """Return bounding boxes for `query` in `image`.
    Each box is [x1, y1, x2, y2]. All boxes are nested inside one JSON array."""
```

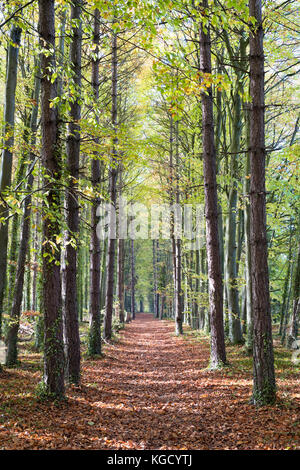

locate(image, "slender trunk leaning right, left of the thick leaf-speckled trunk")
[[6, 60, 41, 366]]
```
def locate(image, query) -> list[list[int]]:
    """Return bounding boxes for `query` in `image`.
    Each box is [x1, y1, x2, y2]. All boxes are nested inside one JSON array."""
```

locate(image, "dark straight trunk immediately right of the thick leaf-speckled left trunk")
[[64, 0, 82, 385]]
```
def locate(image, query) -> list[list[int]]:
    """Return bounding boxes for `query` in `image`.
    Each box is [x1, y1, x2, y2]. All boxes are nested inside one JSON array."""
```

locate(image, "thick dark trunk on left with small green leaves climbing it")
[[39, 0, 64, 399]]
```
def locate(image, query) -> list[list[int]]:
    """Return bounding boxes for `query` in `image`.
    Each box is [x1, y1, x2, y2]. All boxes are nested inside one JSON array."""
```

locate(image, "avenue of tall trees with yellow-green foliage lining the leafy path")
[[0, 0, 300, 405]]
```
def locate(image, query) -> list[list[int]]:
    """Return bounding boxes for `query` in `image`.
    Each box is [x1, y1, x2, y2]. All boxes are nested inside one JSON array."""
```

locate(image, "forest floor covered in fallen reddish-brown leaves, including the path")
[[0, 314, 300, 450]]
